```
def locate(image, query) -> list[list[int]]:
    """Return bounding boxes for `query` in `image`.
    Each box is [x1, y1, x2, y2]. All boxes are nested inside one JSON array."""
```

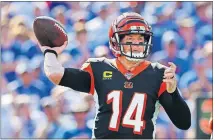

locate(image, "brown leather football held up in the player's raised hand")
[[33, 16, 68, 48]]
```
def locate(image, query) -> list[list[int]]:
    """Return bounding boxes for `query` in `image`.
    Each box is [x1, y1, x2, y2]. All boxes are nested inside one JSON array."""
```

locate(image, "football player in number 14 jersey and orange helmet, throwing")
[[41, 12, 191, 139]]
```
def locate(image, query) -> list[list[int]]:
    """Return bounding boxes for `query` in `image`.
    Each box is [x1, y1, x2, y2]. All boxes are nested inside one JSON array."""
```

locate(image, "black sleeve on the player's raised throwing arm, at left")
[[59, 68, 91, 93]]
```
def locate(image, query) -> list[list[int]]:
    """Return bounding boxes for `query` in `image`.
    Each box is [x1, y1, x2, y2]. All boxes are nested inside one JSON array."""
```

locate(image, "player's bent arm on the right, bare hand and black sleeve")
[[159, 62, 191, 130]]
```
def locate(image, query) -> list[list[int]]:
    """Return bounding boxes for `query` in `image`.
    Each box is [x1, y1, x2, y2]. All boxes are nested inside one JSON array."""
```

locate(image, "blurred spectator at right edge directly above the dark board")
[[179, 49, 212, 99]]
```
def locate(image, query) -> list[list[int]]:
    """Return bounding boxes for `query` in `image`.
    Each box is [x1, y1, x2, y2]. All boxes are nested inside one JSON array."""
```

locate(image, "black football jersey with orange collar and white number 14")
[[82, 58, 166, 139]]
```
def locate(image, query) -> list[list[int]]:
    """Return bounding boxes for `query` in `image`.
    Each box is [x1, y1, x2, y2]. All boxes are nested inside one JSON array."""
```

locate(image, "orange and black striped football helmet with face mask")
[[109, 12, 153, 59]]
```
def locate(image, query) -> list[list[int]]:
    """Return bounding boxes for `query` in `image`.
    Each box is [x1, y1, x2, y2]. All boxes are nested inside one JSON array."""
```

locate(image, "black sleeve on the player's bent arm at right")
[[159, 89, 191, 130]]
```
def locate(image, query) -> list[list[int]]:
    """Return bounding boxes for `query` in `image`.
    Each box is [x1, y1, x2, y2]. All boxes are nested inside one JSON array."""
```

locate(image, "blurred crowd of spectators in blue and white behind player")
[[1, 1, 213, 139]]
